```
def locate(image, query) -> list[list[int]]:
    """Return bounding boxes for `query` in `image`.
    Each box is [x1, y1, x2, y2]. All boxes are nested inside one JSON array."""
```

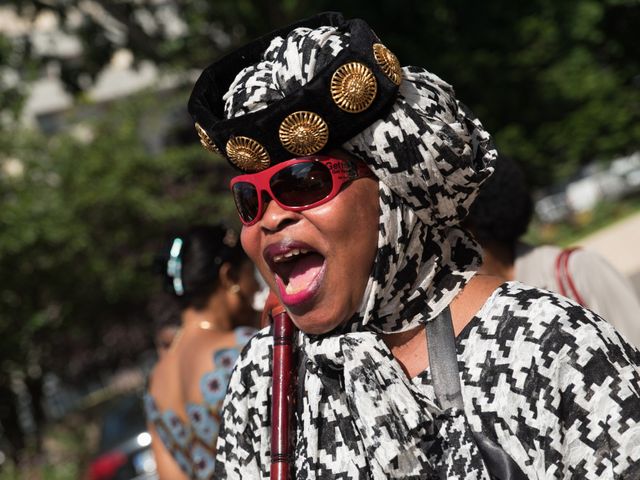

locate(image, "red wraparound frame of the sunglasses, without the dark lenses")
[[230, 155, 374, 226]]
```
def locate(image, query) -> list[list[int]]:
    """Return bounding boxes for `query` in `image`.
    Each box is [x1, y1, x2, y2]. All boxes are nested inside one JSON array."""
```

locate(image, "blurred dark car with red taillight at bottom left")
[[85, 394, 158, 480]]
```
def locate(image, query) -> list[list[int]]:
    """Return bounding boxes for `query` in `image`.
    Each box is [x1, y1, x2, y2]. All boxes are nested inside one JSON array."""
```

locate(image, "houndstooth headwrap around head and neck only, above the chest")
[[224, 23, 496, 332]]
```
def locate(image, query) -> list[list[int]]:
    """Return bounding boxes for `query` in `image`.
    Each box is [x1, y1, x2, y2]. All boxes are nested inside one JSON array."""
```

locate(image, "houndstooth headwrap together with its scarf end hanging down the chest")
[[212, 17, 496, 478]]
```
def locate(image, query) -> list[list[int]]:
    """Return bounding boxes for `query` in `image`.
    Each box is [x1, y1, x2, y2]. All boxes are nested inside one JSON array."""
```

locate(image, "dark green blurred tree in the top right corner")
[[328, 0, 640, 187]]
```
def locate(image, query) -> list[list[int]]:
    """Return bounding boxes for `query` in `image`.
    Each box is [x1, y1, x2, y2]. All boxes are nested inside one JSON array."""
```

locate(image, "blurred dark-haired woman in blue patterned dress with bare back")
[[145, 226, 259, 480]]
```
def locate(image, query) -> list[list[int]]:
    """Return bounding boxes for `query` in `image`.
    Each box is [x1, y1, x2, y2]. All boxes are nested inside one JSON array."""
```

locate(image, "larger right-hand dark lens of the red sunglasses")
[[270, 162, 332, 207]]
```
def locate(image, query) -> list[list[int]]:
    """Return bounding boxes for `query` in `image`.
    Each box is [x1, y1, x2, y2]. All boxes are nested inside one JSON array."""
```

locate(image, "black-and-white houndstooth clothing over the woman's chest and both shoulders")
[[217, 282, 640, 480]]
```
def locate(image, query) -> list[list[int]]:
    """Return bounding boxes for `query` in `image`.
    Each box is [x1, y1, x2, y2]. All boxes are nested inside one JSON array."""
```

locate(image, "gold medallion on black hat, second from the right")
[[331, 62, 378, 113]]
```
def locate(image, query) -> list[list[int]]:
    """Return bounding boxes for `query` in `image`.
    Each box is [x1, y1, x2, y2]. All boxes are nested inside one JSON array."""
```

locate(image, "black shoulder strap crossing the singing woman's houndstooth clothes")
[[425, 307, 527, 480]]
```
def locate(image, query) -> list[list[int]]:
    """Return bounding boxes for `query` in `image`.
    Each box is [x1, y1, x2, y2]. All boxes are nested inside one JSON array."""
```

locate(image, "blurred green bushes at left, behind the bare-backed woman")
[[0, 92, 234, 382]]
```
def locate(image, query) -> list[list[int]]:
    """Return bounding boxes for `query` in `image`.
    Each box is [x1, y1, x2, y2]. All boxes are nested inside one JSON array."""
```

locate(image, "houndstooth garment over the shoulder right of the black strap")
[[414, 282, 640, 480]]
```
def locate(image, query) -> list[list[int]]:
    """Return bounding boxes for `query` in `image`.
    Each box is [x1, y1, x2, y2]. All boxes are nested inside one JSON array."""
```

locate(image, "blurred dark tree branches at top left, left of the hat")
[[5, 0, 314, 93]]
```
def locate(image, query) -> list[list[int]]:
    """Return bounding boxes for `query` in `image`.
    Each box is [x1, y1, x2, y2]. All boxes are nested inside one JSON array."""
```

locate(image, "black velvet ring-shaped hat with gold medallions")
[[189, 12, 402, 172]]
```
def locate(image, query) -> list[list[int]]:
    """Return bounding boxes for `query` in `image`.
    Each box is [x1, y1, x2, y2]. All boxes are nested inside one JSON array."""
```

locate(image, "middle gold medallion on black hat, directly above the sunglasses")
[[278, 111, 329, 156]]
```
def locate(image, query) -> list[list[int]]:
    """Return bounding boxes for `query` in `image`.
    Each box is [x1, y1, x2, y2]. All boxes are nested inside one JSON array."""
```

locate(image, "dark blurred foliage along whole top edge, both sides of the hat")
[[5, 0, 640, 186]]
